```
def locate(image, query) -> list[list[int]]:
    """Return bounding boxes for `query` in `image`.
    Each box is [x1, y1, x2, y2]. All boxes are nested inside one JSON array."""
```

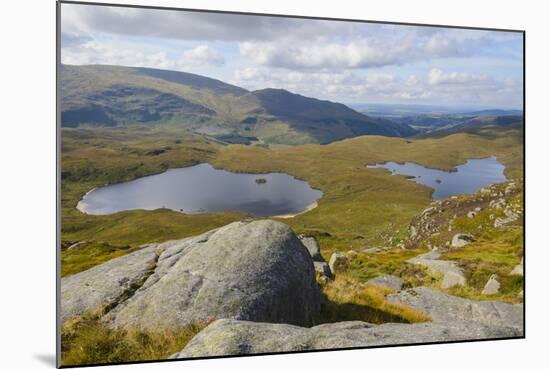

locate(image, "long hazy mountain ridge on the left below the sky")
[[61, 65, 416, 144]]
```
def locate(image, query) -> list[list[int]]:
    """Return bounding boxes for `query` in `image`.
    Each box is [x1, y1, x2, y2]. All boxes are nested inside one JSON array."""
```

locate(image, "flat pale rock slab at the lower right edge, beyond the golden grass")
[[387, 287, 523, 334]]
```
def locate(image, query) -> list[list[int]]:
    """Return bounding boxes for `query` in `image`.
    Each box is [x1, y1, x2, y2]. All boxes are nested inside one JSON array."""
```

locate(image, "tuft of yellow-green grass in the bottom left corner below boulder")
[[61, 316, 208, 365]]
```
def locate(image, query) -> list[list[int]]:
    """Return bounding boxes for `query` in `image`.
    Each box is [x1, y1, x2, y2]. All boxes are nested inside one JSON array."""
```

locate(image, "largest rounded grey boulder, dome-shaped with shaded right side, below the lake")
[[62, 220, 320, 331]]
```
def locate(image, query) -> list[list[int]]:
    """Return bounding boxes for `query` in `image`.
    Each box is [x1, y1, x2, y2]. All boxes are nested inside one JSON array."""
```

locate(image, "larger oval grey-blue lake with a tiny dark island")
[[78, 164, 323, 216]]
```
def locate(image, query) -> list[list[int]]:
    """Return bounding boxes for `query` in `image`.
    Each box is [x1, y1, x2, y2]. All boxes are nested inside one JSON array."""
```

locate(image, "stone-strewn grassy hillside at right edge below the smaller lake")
[[402, 180, 524, 303]]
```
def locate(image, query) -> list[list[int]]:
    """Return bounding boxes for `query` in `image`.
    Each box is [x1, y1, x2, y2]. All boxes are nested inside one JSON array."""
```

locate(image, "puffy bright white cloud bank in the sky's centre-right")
[[239, 30, 500, 70]]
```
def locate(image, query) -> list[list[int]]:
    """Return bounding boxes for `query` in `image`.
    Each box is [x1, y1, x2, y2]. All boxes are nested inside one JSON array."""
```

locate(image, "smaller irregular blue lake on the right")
[[367, 156, 506, 199]]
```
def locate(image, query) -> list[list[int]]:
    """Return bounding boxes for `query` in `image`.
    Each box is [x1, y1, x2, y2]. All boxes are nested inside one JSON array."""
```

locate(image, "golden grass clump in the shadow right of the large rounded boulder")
[[321, 274, 430, 324]]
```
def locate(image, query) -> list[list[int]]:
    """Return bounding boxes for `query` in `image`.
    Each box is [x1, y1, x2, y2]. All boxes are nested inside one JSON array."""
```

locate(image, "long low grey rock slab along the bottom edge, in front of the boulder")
[[175, 319, 521, 358]]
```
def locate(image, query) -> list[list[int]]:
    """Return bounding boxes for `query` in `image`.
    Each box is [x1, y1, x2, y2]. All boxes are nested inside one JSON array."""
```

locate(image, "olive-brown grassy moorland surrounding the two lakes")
[[61, 122, 523, 280]]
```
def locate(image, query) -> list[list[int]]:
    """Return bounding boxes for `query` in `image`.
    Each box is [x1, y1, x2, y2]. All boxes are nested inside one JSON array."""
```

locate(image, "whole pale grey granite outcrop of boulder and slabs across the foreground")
[[61, 220, 523, 358]]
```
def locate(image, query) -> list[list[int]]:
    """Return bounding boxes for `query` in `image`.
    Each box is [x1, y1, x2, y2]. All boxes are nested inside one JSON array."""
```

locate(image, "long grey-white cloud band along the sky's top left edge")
[[61, 4, 353, 41]]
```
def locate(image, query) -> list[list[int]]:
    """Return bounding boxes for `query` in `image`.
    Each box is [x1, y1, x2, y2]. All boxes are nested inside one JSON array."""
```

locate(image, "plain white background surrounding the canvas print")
[[0, 0, 550, 369]]
